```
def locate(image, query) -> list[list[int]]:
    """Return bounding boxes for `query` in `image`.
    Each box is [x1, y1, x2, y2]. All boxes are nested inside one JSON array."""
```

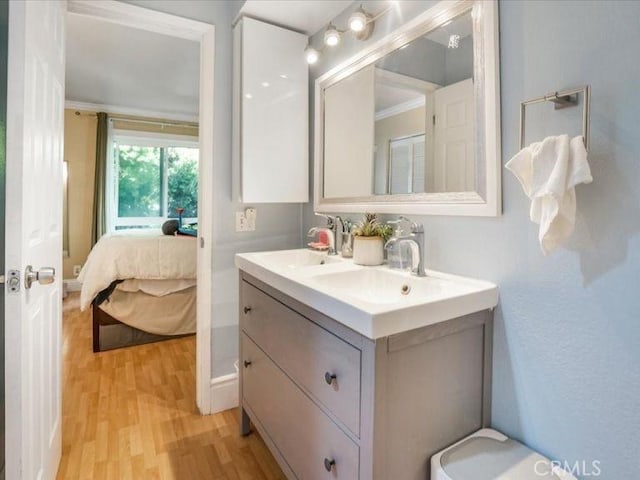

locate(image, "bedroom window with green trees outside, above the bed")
[[109, 134, 199, 230]]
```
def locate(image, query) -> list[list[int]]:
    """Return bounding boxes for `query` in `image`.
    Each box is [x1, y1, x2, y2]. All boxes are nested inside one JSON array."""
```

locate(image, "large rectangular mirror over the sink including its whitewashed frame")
[[314, 0, 502, 216]]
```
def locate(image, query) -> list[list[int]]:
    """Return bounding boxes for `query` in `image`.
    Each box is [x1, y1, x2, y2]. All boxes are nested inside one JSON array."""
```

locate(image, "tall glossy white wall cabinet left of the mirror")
[[233, 17, 309, 203]]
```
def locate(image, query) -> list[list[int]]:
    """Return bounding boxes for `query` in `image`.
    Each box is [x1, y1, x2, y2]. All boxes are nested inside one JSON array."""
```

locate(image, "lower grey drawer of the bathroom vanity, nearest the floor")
[[242, 334, 359, 480]]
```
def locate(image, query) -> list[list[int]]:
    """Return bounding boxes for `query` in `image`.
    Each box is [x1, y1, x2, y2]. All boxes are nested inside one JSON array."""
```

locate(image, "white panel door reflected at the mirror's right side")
[[433, 78, 476, 192]]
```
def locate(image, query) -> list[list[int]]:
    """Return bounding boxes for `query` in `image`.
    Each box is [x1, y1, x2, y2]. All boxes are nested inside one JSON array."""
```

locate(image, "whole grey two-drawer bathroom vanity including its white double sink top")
[[236, 250, 497, 480]]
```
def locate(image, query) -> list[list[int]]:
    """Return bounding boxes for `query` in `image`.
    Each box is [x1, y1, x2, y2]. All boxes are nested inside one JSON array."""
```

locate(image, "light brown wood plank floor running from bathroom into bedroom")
[[58, 294, 285, 480]]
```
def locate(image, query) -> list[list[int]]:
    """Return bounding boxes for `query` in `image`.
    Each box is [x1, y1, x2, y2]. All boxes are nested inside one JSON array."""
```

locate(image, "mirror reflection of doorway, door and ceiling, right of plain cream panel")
[[373, 12, 476, 195]]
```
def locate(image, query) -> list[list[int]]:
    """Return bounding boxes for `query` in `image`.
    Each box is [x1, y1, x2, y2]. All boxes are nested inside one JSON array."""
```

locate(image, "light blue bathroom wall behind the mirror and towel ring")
[[303, 0, 640, 480]]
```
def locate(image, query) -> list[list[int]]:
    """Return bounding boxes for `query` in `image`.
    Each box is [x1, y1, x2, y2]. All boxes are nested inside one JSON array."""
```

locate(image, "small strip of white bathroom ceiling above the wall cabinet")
[[240, 0, 353, 35]]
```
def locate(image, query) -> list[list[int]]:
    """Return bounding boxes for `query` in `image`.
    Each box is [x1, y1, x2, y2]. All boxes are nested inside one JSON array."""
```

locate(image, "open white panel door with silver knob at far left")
[[5, 0, 66, 480]]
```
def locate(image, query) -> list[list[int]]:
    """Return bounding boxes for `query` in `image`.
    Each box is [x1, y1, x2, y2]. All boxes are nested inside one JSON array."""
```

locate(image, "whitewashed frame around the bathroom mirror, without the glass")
[[313, 0, 502, 217]]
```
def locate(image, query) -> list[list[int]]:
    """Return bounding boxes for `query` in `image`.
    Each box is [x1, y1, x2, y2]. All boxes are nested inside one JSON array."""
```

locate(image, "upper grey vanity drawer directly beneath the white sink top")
[[241, 282, 361, 436]]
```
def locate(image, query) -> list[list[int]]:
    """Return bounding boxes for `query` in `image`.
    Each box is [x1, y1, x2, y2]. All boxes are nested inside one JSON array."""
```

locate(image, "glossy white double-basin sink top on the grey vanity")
[[236, 250, 498, 340]]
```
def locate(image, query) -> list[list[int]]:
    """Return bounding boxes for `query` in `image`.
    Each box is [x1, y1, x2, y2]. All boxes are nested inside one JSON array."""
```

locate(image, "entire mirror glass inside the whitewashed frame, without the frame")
[[324, 11, 476, 198]]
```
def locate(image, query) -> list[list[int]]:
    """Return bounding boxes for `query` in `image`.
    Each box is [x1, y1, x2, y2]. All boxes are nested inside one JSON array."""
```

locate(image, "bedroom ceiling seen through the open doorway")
[[66, 14, 200, 118]]
